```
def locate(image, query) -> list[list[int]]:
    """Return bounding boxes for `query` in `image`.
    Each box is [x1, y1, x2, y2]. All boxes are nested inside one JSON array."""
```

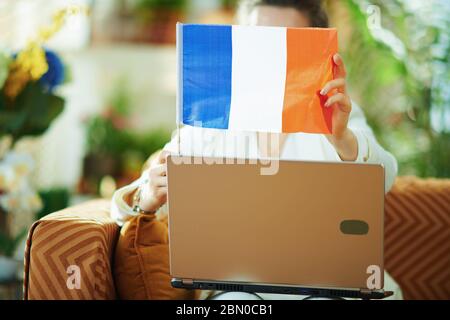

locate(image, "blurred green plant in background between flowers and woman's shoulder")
[[80, 78, 171, 194]]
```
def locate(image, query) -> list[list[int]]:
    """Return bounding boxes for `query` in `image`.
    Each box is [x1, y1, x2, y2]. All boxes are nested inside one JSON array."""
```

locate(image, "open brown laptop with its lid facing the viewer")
[[167, 155, 392, 299]]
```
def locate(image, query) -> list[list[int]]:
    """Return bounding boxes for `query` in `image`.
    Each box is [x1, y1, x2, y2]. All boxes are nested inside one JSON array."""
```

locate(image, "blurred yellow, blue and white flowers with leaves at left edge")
[[0, 7, 84, 281]]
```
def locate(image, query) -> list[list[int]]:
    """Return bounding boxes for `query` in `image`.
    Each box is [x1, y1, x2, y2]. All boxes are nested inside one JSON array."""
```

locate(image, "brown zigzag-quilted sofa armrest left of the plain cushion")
[[24, 200, 119, 300]]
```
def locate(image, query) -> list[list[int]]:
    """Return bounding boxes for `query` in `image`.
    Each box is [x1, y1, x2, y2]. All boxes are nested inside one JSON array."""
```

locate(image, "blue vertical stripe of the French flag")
[[182, 25, 232, 129]]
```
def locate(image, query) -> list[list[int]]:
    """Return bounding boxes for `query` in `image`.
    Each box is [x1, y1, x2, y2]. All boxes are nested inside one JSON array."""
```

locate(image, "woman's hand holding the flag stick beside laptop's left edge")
[[139, 151, 168, 212]]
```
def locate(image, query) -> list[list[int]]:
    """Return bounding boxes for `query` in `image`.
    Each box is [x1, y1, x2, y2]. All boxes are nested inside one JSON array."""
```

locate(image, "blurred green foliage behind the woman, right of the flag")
[[326, 0, 450, 177]]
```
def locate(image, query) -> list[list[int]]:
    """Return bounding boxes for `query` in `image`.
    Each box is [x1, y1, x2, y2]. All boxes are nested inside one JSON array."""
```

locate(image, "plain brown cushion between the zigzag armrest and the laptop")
[[114, 215, 198, 299]]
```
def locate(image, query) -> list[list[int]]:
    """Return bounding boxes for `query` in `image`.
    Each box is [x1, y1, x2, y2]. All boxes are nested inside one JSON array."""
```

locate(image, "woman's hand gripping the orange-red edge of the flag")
[[320, 54, 358, 161]]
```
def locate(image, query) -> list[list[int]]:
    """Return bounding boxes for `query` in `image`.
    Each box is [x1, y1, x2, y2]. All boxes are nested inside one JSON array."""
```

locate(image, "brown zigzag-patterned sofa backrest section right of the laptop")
[[384, 177, 450, 299]]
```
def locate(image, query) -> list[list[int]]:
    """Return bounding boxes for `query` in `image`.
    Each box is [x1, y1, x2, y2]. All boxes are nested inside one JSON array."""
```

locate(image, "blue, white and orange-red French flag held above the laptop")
[[177, 23, 338, 134]]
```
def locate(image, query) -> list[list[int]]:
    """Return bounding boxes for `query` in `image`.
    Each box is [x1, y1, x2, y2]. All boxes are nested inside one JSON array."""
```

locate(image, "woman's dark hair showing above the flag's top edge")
[[241, 0, 329, 28]]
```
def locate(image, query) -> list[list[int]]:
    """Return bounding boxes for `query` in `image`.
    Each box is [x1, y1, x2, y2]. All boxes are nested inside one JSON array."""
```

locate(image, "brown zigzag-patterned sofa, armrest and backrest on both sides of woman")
[[24, 177, 450, 299]]
